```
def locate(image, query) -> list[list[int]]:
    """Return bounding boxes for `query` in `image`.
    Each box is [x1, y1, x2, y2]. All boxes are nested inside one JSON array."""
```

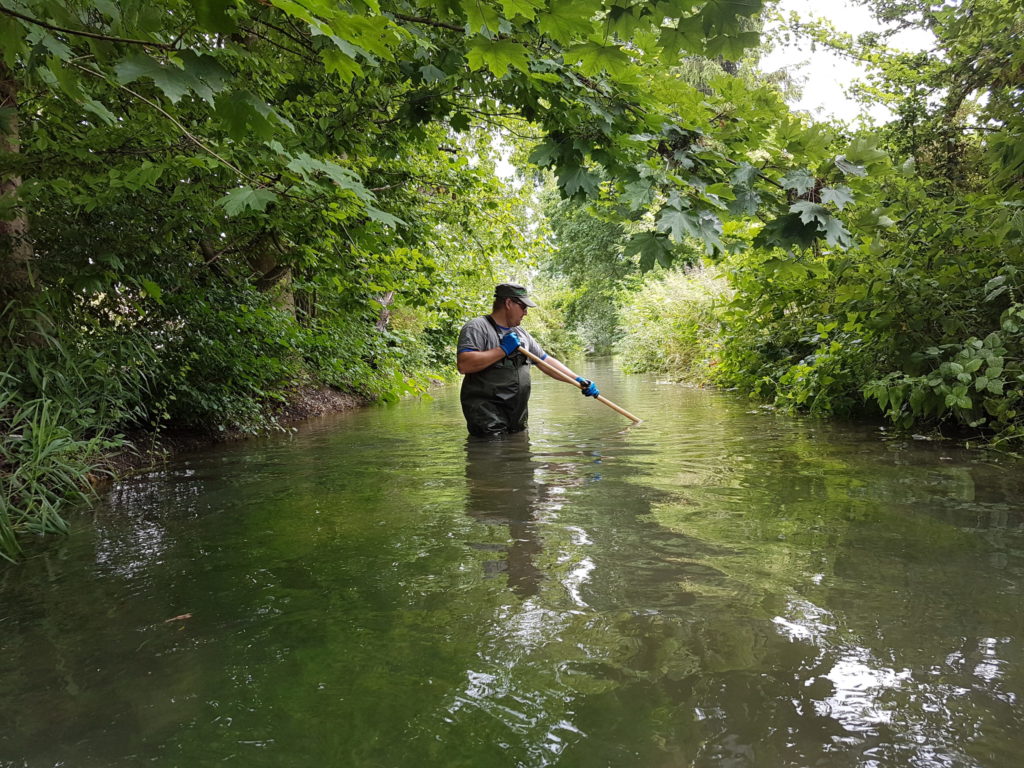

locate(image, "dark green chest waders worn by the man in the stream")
[[459, 316, 529, 435]]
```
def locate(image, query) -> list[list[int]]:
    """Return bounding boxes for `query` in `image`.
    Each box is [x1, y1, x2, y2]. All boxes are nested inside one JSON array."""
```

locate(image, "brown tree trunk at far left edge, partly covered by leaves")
[[0, 60, 33, 299]]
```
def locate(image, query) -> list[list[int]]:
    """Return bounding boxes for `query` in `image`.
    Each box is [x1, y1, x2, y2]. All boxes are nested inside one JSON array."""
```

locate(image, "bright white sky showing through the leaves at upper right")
[[761, 0, 935, 125]]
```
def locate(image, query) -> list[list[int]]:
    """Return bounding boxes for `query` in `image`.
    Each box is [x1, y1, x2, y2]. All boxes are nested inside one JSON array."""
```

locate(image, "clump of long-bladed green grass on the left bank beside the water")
[[0, 305, 138, 560]]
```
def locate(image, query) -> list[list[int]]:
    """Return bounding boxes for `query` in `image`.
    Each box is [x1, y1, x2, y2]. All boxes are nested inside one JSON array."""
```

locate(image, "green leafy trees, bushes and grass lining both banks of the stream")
[[0, 0, 1024, 557]]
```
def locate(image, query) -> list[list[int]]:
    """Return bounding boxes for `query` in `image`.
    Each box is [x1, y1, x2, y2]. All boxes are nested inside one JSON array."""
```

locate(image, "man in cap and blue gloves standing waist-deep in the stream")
[[458, 283, 600, 436]]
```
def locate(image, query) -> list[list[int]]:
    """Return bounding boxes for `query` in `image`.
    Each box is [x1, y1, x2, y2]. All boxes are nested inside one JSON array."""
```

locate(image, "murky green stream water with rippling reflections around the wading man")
[[0, 364, 1024, 768]]
